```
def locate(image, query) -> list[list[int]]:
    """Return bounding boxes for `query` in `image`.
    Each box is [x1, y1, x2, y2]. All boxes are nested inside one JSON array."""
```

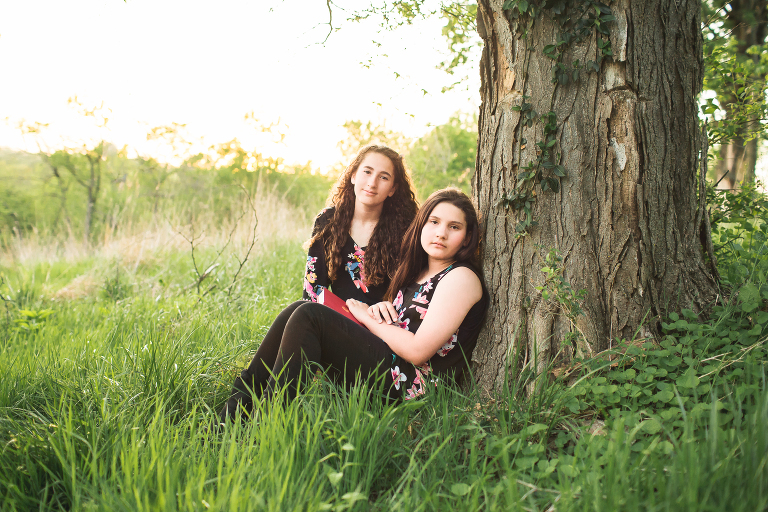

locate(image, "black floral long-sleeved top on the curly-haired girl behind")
[[303, 207, 389, 304]]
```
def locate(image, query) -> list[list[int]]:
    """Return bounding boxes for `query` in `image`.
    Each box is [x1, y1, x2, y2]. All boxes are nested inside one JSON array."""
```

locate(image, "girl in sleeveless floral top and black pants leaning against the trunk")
[[219, 188, 488, 423]]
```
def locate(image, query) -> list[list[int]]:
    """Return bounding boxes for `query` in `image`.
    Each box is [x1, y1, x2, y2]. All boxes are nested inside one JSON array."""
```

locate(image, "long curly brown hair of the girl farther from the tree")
[[309, 145, 419, 286]]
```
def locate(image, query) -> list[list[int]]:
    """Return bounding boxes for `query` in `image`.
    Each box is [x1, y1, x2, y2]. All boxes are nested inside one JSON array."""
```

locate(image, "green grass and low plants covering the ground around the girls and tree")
[[0, 183, 768, 511]]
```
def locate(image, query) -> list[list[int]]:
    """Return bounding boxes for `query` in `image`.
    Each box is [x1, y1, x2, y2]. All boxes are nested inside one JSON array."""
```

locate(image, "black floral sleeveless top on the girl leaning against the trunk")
[[391, 263, 488, 400]]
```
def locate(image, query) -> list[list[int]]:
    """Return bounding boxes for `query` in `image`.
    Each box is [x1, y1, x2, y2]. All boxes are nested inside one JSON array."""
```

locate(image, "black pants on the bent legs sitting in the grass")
[[220, 300, 403, 421]]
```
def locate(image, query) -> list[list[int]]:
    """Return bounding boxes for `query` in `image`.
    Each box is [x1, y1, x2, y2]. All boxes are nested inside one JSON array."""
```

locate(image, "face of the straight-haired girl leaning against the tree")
[[421, 202, 467, 262]]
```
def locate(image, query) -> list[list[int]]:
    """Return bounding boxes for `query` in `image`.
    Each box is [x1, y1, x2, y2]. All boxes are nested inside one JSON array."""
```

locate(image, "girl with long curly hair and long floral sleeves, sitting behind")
[[304, 145, 418, 304]]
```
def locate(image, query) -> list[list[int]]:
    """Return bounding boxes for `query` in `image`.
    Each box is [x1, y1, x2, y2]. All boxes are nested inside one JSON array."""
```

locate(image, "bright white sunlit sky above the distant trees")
[[0, 0, 479, 168]]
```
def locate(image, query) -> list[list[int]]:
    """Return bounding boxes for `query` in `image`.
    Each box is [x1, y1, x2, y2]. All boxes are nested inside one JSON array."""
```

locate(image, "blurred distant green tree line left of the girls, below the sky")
[[0, 141, 333, 245]]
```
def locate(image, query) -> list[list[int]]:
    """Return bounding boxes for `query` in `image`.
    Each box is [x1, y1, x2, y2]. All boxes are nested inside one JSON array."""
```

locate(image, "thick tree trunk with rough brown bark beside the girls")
[[473, 0, 716, 390]]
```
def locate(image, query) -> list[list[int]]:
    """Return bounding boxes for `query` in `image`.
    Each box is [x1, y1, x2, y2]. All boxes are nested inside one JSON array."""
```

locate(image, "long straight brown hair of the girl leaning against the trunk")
[[384, 187, 480, 300]]
